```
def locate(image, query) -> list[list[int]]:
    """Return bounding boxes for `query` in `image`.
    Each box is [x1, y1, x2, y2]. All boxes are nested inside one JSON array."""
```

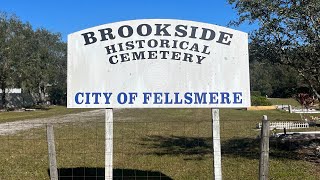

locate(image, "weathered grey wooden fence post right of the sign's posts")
[[259, 115, 270, 180]]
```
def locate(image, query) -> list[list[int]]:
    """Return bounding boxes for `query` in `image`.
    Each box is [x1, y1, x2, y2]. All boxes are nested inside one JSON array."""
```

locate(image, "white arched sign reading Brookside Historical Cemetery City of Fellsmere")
[[68, 19, 250, 108]]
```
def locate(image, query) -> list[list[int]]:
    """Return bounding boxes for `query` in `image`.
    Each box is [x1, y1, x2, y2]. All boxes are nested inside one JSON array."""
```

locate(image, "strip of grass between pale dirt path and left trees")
[[0, 106, 90, 123]]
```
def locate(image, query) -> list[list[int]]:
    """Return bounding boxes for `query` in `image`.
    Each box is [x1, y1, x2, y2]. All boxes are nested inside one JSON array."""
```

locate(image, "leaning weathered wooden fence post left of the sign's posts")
[[47, 124, 58, 180]]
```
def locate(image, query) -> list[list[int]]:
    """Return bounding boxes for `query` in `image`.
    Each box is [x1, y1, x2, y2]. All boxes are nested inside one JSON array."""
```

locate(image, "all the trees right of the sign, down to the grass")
[[228, 0, 320, 99]]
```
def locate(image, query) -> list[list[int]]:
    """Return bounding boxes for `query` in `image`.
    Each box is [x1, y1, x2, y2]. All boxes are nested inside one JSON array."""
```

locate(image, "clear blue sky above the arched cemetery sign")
[[0, 0, 253, 41]]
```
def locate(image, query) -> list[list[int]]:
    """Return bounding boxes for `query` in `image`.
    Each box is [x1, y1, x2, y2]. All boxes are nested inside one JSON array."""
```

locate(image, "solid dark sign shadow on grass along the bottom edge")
[[48, 167, 172, 180]]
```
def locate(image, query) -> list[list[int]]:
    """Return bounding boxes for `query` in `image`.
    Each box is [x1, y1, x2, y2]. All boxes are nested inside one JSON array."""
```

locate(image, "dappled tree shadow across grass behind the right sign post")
[[141, 136, 299, 160]]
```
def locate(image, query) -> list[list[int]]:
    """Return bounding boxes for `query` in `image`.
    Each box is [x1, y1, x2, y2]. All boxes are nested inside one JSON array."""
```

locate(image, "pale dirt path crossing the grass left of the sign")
[[0, 109, 107, 136]]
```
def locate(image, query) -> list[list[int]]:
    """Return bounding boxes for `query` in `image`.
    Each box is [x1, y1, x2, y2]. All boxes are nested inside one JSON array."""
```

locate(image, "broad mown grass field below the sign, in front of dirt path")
[[0, 109, 320, 180]]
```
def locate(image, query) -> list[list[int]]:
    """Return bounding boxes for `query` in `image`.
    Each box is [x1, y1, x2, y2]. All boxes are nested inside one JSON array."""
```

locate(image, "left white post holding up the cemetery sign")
[[105, 109, 113, 180]]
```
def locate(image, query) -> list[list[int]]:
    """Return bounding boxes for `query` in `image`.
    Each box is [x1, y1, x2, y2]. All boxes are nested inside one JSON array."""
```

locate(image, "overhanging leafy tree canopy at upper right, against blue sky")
[[228, 0, 320, 99]]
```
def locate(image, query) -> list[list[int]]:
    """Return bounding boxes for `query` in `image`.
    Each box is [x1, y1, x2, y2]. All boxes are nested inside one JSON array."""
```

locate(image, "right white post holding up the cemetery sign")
[[211, 109, 222, 180]]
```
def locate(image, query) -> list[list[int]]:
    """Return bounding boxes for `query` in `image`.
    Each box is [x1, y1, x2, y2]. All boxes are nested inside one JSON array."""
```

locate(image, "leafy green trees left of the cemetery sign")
[[0, 12, 67, 108]]
